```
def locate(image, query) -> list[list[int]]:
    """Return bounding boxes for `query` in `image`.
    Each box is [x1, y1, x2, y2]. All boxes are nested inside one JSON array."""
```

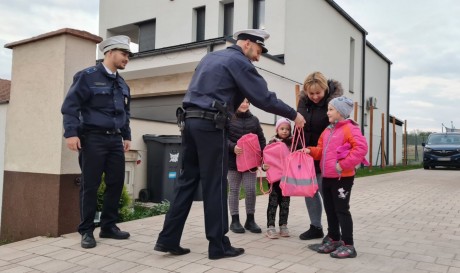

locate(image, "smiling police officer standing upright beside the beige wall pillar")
[[61, 35, 132, 248]]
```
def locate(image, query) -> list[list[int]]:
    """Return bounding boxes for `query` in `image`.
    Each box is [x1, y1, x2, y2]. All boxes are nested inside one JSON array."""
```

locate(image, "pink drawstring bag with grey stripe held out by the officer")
[[280, 126, 318, 197]]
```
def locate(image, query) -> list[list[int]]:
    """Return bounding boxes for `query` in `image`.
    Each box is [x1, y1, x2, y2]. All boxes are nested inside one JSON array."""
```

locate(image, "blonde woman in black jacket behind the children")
[[297, 72, 343, 240]]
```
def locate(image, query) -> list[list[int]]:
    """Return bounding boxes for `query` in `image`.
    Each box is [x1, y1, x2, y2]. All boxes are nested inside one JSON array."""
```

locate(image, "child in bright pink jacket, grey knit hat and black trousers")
[[305, 96, 367, 258]]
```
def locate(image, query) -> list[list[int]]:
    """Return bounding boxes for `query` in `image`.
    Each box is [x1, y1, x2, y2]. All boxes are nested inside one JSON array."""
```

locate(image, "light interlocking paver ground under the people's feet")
[[0, 169, 460, 273]]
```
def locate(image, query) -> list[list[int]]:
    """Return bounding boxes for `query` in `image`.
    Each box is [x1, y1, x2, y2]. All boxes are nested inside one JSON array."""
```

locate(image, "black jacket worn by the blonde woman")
[[297, 80, 343, 173]]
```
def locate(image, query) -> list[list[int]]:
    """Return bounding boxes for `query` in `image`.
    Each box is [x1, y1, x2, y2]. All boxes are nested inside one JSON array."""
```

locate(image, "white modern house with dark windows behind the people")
[[99, 0, 393, 200]]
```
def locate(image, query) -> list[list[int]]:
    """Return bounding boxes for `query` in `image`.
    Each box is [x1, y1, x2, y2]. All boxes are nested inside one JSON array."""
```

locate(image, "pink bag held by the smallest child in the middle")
[[263, 141, 289, 184]]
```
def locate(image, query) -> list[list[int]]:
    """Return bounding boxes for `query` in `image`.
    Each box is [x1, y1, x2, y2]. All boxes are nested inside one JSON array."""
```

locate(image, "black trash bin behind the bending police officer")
[[142, 135, 203, 203]]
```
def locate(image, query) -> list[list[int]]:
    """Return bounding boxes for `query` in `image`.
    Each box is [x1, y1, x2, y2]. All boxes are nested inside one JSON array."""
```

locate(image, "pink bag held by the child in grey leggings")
[[236, 133, 262, 172]]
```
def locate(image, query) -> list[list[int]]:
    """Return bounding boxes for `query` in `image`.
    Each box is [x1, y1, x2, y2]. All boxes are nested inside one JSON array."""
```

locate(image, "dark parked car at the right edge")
[[422, 132, 460, 169]]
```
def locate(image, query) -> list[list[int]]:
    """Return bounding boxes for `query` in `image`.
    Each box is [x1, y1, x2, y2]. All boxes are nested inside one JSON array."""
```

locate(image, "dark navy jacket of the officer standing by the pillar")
[[61, 63, 131, 140]]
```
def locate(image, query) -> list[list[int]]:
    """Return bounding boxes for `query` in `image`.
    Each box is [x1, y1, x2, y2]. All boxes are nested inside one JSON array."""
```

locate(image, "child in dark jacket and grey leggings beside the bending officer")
[[228, 99, 266, 233]]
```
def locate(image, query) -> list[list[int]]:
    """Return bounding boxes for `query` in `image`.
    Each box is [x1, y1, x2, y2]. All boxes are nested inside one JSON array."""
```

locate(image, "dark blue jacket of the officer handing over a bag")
[[183, 45, 297, 120]]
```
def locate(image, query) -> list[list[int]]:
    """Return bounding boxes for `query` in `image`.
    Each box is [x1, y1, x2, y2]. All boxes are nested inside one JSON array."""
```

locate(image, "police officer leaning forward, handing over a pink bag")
[[154, 29, 305, 259]]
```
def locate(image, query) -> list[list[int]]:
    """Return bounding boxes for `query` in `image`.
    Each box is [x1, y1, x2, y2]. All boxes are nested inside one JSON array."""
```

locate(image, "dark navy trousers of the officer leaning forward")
[[157, 118, 231, 256]]
